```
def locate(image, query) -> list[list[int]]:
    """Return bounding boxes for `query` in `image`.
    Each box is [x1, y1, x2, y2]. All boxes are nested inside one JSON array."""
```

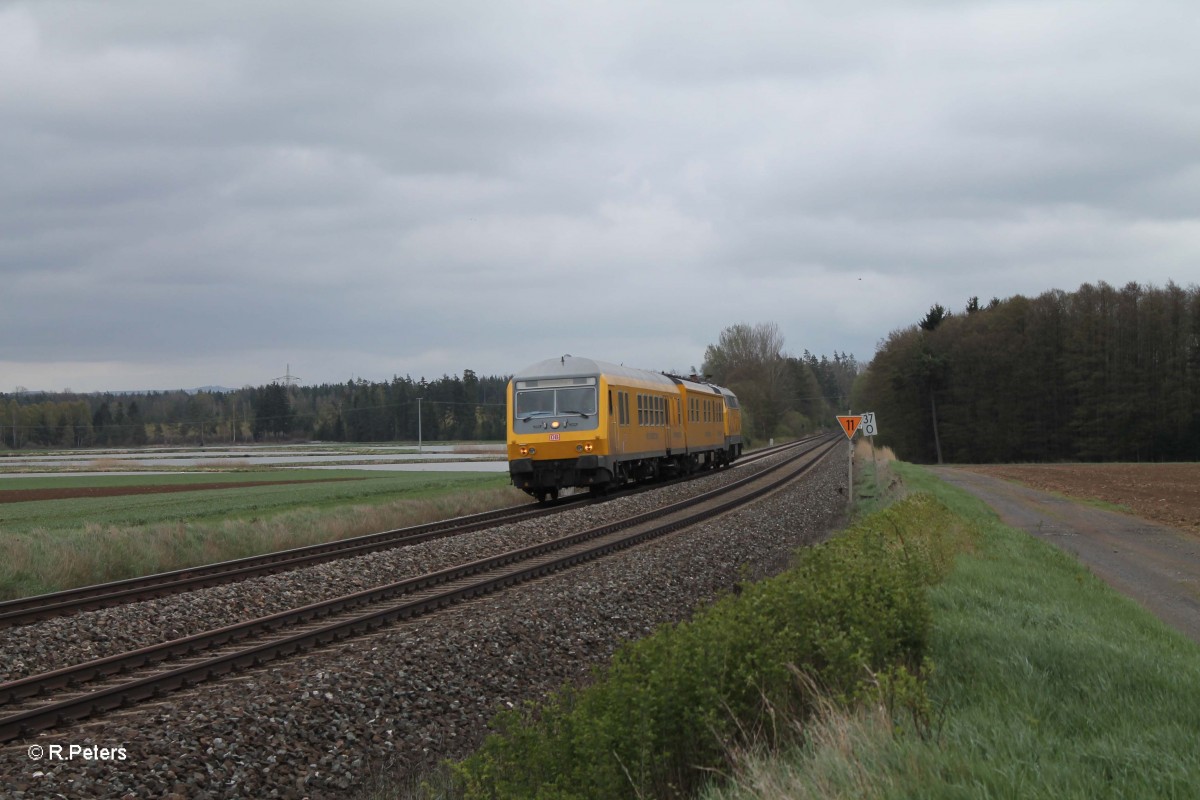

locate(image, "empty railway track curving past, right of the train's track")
[[0, 439, 836, 741]]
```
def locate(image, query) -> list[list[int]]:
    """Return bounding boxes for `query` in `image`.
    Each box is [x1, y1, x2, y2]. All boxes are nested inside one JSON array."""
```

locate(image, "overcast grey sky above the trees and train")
[[0, 0, 1200, 392]]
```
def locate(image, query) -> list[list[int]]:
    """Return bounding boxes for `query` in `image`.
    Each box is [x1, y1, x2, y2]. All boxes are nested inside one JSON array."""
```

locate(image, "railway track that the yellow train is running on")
[[0, 440, 808, 630]]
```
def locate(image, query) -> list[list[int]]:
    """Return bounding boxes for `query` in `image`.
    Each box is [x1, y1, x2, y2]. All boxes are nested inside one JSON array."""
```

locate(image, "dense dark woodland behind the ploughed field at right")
[[854, 283, 1200, 463]]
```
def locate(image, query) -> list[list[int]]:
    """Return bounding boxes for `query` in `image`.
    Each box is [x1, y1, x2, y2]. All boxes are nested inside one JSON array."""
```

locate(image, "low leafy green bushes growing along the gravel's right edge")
[[426, 495, 961, 800]]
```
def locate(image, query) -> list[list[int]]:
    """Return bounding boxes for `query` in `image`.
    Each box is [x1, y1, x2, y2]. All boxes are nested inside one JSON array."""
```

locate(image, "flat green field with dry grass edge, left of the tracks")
[[0, 470, 527, 600]]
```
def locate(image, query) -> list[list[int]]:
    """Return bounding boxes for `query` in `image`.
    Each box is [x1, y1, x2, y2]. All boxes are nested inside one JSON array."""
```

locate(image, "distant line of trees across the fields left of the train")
[[0, 369, 508, 449]]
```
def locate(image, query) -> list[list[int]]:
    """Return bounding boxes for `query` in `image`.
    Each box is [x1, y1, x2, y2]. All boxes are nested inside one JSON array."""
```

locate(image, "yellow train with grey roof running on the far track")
[[508, 355, 743, 500]]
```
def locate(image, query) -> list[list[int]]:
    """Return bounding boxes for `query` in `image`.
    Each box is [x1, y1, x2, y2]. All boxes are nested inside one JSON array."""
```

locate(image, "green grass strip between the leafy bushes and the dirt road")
[[703, 464, 1200, 800]]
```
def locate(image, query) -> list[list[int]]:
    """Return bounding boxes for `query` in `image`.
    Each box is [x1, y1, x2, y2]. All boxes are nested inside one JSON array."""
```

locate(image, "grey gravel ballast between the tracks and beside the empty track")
[[0, 450, 845, 798]]
